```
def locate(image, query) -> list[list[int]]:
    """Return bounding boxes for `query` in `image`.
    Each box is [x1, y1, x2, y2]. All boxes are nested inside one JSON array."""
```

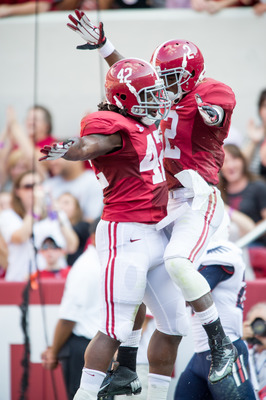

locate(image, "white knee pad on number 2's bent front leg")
[[165, 257, 211, 301]]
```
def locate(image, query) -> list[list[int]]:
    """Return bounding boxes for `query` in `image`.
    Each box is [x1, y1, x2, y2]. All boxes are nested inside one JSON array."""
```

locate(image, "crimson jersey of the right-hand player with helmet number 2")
[[160, 78, 236, 190]]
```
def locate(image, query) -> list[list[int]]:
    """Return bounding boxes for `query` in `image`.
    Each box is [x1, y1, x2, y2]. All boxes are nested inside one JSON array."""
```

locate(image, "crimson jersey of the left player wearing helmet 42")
[[80, 111, 167, 224]]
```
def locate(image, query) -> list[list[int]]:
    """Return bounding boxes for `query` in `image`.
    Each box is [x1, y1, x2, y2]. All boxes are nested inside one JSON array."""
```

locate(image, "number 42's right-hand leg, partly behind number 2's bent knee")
[[144, 256, 188, 400]]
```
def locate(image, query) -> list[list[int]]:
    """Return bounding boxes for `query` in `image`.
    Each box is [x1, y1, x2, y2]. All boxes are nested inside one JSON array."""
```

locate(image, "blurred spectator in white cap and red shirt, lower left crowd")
[[31, 233, 70, 280]]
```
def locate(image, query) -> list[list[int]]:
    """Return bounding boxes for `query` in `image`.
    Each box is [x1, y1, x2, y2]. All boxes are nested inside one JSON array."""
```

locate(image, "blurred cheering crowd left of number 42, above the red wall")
[[0, 106, 103, 281]]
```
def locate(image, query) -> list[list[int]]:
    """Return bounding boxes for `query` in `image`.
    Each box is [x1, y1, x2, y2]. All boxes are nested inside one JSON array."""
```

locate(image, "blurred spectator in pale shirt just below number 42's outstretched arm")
[[44, 158, 103, 222]]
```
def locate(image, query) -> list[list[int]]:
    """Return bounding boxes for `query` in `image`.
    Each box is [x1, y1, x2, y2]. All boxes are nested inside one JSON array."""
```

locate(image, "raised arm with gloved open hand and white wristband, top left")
[[67, 10, 125, 67]]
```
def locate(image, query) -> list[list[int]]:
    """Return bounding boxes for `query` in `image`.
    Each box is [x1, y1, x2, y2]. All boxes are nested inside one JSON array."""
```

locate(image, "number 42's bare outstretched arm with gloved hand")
[[39, 133, 122, 161]]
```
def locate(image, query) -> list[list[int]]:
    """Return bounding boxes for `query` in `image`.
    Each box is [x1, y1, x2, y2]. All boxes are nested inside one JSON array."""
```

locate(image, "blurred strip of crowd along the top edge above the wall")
[[0, 0, 266, 18]]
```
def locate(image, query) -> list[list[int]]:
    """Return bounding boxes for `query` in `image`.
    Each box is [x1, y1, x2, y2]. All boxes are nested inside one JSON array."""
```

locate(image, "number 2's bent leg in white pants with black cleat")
[[165, 188, 237, 383]]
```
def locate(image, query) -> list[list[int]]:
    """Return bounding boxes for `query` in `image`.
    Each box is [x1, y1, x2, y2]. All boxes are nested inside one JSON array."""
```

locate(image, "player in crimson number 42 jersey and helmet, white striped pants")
[[40, 59, 188, 400]]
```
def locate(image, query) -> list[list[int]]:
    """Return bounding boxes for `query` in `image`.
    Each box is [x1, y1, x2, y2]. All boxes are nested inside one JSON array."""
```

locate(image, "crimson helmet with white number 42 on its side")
[[105, 58, 171, 125]]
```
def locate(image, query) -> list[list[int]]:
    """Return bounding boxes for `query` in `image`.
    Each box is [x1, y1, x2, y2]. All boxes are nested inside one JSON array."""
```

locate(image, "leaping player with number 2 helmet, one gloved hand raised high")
[[68, 10, 237, 396]]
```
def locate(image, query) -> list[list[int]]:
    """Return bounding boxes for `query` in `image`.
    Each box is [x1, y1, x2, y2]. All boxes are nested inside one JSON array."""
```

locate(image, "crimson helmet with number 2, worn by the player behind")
[[151, 40, 205, 101]]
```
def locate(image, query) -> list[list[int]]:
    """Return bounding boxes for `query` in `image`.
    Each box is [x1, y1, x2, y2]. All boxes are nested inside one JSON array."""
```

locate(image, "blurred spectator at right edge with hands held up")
[[243, 89, 266, 175]]
